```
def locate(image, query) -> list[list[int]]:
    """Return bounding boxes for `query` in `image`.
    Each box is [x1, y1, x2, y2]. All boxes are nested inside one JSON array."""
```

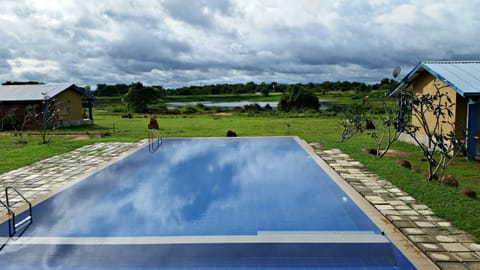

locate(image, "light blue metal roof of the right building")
[[388, 61, 480, 97]]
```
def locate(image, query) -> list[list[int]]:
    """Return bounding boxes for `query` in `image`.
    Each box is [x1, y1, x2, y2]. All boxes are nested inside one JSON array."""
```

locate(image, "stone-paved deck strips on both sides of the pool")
[[0, 142, 480, 269]]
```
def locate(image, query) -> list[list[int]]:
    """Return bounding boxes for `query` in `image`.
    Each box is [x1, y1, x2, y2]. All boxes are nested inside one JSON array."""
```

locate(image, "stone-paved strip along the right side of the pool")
[[310, 143, 480, 270]]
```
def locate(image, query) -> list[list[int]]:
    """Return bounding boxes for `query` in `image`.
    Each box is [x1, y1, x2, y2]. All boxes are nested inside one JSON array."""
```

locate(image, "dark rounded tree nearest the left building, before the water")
[[124, 82, 160, 113]]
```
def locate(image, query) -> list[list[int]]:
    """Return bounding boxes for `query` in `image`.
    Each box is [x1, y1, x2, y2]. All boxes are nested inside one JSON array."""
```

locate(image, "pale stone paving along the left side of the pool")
[[0, 143, 142, 220]]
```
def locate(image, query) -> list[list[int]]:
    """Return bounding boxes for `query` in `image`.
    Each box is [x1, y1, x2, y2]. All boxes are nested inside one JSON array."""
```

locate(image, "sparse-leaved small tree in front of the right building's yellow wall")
[[402, 79, 465, 181]]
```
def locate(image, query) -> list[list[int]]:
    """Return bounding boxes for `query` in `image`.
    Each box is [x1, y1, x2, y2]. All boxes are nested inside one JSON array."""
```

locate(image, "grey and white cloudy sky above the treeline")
[[0, 0, 480, 88]]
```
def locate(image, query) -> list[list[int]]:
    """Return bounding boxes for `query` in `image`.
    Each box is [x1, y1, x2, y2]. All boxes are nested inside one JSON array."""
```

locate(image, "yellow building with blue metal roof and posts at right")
[[389, 61, 480, 160]]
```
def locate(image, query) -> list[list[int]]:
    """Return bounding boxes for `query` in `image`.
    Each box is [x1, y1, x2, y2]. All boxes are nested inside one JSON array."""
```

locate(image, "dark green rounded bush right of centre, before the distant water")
[[278, 85, 320, 112]]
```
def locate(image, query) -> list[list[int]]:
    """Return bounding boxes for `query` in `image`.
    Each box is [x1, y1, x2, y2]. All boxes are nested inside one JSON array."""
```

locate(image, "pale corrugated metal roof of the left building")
[[0, 83, 90, 101]]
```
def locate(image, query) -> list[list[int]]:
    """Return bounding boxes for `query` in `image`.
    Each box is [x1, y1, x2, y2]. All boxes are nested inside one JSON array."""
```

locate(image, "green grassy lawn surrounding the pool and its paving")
[[0, 108, 480, 239]]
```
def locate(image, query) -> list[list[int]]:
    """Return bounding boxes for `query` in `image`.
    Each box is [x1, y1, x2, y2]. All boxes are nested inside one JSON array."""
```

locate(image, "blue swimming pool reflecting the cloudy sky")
[[0, 137, 414, 269]]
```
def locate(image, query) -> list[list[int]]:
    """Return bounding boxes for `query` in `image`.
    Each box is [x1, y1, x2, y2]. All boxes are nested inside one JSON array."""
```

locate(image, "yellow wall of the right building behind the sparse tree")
[[412, 72, 458, 135]]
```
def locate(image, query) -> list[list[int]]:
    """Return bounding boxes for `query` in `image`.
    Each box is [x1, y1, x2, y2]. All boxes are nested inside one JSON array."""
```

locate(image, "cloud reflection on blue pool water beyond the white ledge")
[[15, 138, 374, 236]]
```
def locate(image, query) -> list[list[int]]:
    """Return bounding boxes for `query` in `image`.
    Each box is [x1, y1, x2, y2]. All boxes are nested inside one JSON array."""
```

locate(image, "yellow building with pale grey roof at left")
[[0, 84, 95, 129]]
